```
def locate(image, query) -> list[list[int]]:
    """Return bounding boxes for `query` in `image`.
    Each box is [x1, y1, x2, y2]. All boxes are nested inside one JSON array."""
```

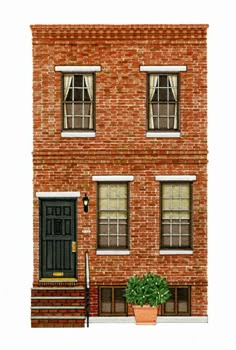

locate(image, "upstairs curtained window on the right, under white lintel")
[[148, 73, 179, 131]]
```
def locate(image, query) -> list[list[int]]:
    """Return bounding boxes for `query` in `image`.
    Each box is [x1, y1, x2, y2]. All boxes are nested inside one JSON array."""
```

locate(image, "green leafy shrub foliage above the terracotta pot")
[[125, 272, 171, 306]]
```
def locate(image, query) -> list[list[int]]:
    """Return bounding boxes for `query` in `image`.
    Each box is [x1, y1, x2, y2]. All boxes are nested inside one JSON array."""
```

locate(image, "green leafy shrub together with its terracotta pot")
[[125, 272, 171, 324]]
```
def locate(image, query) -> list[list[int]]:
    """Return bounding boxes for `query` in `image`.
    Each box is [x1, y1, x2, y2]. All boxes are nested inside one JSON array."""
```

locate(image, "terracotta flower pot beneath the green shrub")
[[133, 305, 158, 325]]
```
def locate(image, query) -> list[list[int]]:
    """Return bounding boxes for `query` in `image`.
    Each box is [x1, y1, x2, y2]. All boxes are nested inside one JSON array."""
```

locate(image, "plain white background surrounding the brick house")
[[0, 0, 236, 350]]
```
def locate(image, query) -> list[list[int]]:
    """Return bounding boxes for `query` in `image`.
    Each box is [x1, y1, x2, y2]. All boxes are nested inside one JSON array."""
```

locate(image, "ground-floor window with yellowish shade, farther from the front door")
[[161, 182, 191, 249]]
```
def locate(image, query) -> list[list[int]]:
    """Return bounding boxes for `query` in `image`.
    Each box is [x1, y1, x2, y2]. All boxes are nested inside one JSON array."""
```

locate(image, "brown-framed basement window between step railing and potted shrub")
[[99, 286, 127, 316]]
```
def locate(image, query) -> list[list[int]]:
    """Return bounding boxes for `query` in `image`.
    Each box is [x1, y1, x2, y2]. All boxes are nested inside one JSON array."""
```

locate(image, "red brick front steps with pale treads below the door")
[[31, 287, 85, 327]]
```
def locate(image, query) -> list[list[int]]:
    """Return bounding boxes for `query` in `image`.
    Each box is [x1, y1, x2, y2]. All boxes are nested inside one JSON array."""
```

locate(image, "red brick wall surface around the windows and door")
[[32, 25, 207, 315]]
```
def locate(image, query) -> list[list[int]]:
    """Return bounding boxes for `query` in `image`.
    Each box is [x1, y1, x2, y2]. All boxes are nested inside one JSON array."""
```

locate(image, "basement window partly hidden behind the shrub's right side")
[[162, 286, 191, 316]]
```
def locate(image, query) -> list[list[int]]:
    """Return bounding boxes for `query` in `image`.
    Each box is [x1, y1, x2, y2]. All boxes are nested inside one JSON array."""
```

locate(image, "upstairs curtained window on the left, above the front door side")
[[63, 73, 95, 131]]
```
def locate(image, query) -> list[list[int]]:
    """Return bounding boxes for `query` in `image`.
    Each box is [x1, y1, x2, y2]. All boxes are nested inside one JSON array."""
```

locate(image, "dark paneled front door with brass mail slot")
[[40, 198, 77, 278]]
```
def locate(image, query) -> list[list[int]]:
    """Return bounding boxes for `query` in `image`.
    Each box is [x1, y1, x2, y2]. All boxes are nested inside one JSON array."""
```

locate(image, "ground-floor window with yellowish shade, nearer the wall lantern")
[[98, 182, 128, 249]]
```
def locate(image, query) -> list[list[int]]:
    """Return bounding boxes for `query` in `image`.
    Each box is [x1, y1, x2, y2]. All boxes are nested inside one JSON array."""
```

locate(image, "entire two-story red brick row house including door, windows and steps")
[[31, 25, 207, 327]]
